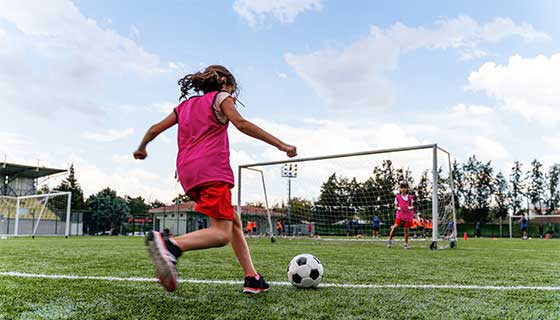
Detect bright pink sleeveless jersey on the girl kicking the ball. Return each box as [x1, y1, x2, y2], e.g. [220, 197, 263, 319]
[175, 91, 234, 192]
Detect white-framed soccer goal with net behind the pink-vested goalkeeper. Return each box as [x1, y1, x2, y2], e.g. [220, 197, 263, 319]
[237, 144, 457, 249]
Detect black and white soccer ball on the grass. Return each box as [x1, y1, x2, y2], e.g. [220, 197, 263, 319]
[288, 253, 323, 288]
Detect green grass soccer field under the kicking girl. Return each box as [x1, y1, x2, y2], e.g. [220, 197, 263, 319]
[0, 237, 560, 319]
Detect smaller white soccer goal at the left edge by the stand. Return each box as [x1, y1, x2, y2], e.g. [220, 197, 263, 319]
[0, 192, 75, 237]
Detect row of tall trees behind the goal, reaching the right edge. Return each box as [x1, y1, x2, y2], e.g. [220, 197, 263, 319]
[275, 155, 560, 223]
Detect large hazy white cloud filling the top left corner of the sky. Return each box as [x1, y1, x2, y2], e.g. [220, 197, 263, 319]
[0, 0, 170, 116]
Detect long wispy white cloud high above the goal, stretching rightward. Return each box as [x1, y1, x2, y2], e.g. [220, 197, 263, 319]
[285, 16, 548, 110]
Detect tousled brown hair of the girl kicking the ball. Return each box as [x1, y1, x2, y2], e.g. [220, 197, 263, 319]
[178, 65, 238, 100]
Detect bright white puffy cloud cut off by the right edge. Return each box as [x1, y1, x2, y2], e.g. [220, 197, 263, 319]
[467, 53, 560, 124]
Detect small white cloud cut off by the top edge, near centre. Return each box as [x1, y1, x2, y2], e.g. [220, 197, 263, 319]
[233, 0, 321, 27]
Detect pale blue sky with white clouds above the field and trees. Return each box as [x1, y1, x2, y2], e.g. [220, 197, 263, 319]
[0, 0, 560, 201]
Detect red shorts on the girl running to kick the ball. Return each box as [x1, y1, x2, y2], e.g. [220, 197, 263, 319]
[187, 182, 233, 221]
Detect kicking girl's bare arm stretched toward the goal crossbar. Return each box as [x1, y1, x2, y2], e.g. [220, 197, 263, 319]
[220, 98, 297, 158]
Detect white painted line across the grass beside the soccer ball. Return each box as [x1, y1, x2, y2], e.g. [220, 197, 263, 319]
[0, 272, 560, 291]
